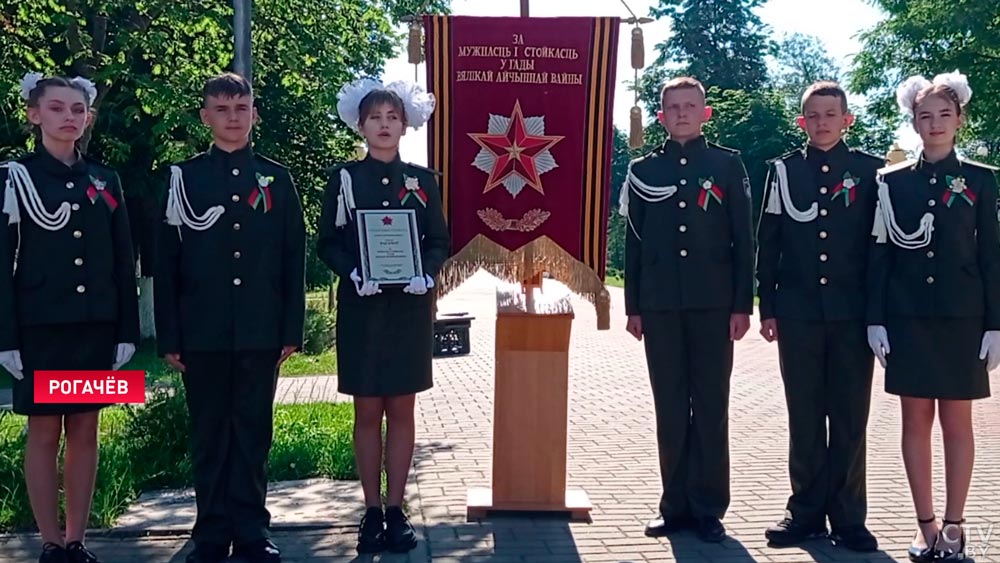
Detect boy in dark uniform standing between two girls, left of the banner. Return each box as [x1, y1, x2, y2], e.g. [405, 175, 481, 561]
[155, 74, 305, 563]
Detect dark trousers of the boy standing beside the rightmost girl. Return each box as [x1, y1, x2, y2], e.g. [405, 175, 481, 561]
[778, 319, 874, 528]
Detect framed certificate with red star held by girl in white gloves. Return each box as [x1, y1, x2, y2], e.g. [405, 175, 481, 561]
[356, 209, 424, 286]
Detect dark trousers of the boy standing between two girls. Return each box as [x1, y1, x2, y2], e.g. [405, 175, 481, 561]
[181, 350, 280, 546]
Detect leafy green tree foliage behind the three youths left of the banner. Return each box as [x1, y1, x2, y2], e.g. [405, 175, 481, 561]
[0, 0, 448, 283]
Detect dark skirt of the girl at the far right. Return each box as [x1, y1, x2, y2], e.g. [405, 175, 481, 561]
[885, 317, 990, 400]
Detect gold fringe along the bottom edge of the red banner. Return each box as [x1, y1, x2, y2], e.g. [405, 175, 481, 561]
[434, 235, 611, 330]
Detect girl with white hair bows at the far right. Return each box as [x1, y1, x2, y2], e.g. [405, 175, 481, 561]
[868, 72, 1000, 561]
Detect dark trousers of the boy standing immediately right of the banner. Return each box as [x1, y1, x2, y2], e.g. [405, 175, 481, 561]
[642, 310, 733, 519]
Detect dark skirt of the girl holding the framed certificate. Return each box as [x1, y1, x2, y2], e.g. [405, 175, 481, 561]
[337, 283, 434, 397]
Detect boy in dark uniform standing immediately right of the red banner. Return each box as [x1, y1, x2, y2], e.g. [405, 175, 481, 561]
[621, 78, 753, 542]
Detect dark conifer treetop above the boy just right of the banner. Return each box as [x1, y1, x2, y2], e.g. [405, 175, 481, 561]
[650, 0, 768, 90]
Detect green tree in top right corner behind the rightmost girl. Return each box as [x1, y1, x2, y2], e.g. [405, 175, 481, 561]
[851, 0, 1000, 161]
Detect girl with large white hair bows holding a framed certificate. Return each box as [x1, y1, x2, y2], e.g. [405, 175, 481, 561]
[317, 80, 449, 553]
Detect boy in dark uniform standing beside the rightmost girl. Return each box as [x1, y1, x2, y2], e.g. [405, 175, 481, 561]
[757, 82, 883, 551]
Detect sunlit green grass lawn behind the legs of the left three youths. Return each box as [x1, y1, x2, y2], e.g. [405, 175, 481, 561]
[0, 388, 357, 532]
